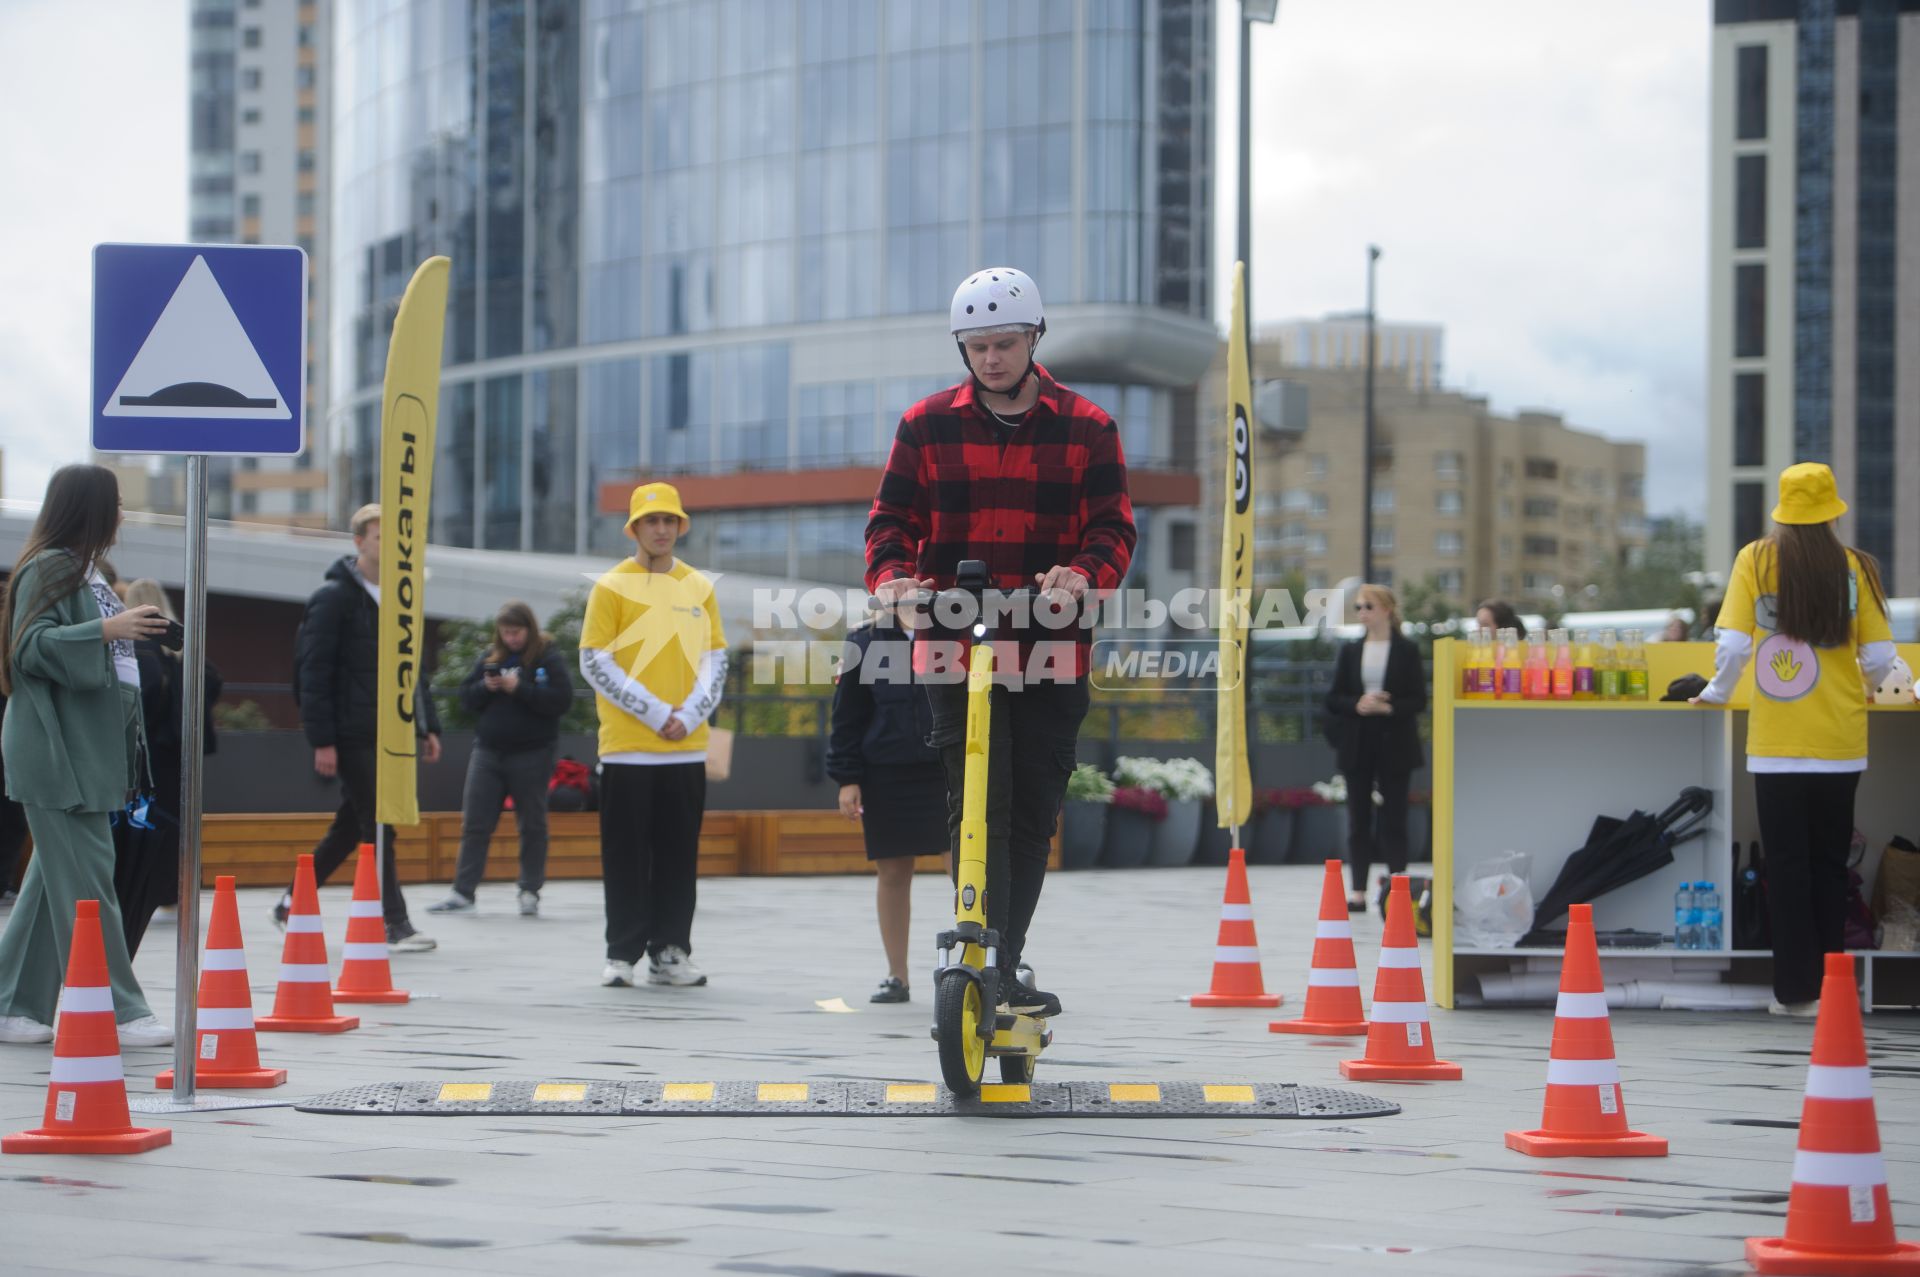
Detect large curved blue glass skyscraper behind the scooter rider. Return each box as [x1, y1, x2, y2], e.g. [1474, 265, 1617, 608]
[328, 0, 1215, 582]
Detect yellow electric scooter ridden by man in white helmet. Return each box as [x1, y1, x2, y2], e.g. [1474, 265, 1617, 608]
[887, 559, 1054, 1098]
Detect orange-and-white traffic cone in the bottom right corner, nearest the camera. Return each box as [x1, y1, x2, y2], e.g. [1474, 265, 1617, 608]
[1747, 952, 1920, 1277]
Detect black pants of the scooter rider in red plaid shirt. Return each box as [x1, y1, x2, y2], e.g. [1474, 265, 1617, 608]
[927, 680, 1087, 968]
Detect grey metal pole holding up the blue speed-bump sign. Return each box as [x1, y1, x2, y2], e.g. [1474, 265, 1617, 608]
[171, 455, 207, 1106]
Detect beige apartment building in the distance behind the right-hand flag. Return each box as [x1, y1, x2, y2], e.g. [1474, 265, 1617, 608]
[1200, 342, 1647, 611]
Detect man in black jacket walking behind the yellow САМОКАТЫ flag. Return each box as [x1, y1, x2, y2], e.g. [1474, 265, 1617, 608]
[273, 505, 440, 952]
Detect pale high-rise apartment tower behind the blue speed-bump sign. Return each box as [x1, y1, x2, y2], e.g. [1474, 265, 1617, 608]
[178, 0, 330, 526]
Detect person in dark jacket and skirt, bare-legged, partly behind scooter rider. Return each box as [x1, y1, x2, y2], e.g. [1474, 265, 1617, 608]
[828, 611, 947, 1002]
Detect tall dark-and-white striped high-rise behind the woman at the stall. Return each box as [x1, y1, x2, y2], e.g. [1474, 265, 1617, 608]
[1707, 0, 1920, 595]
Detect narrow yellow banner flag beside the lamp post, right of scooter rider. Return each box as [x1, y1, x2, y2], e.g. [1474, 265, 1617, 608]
[1213, 261, 1254, 830]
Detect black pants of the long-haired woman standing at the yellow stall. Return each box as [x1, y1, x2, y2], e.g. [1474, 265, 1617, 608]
[1753, 772, 1860, 1002]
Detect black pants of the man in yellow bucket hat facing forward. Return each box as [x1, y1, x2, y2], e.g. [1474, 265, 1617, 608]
[601, 762, 707, 962]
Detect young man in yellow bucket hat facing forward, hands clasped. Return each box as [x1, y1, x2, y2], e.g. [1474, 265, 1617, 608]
[580, 484, 726, 987]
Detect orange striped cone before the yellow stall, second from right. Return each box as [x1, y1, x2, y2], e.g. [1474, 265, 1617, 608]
[1507, 904, 1667, 1158]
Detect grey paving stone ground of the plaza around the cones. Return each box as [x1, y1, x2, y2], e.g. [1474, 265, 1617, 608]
[0, 866, 1920, 1277]
